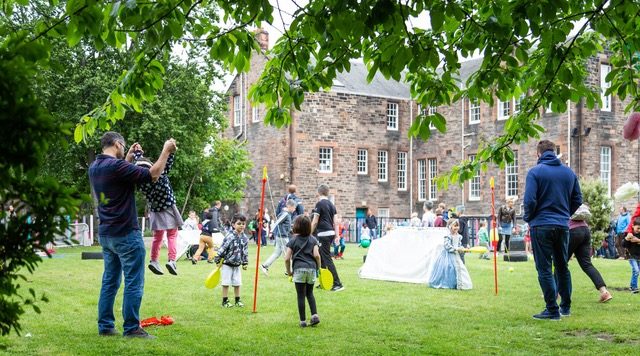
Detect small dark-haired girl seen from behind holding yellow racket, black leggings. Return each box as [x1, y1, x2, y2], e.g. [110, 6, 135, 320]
[284, 215, 320, 328]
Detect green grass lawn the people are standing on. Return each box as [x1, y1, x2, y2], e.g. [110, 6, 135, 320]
[0, 241, 640, 355]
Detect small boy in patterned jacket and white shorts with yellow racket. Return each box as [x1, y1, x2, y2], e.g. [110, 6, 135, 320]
[214, 213, 249, 308]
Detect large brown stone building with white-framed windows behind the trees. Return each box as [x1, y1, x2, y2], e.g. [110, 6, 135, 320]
[225, 32, 640, 218]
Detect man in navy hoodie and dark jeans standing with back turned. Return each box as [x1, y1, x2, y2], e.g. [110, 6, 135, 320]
[524, 140, 582, 320]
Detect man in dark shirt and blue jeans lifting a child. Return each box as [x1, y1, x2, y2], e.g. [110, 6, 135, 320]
[89, 131, 176, 339]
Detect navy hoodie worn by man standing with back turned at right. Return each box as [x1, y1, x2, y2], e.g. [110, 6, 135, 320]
[523, 151, 582, 228]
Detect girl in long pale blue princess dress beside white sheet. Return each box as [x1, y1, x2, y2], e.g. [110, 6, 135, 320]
[429, 218, 473, 289]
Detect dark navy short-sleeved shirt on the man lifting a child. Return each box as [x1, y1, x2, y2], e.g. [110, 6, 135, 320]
[89, 154, 151, 237]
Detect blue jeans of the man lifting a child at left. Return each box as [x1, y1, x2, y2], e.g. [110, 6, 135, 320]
[98, 230, 146, 334]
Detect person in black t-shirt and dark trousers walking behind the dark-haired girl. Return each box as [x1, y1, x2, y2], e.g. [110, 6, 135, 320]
[311, 184, 344, 292]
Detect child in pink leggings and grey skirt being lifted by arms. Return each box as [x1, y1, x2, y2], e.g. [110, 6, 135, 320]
[134, 151, 184, 276]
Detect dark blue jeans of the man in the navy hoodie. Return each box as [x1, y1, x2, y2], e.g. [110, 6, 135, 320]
[531, 226, 571, 313]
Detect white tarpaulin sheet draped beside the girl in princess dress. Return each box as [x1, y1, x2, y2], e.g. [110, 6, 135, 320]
[359, 227, 449, 284]
